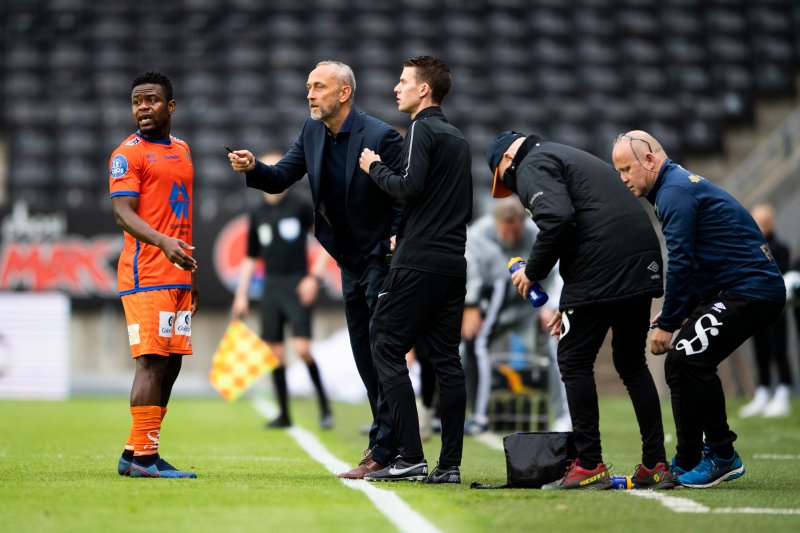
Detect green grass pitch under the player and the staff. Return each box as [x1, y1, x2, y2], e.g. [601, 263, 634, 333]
[0, 397, 800, 533]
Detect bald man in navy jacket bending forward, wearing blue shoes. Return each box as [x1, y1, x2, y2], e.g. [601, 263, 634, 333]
[612, 130, 786, 488]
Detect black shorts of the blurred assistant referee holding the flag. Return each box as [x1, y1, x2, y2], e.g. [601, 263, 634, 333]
[261, 274, 311, 342]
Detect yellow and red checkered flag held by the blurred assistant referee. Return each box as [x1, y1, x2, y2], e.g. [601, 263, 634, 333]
[208, 320, 280, 402]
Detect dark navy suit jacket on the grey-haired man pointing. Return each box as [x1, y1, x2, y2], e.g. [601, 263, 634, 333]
[246, 108, 403, 269]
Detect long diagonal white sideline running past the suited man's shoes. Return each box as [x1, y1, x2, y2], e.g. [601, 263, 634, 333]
[253, 398, 441, 533]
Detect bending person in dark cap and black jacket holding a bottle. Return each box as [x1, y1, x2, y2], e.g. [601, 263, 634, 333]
[487, 131, 674, 490]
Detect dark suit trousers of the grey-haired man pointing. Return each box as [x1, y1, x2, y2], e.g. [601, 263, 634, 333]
[341, 251, 397, 465]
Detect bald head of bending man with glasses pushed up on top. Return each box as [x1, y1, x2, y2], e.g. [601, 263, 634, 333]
[611, 130, 667, 197]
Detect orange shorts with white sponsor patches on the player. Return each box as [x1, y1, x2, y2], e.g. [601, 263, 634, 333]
[121, 289, 192, 358]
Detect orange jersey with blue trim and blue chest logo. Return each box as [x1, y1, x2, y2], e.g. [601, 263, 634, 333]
[108, 133, 194, 295]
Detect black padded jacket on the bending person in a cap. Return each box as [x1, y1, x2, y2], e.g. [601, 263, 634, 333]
[504, 135, 663, 310]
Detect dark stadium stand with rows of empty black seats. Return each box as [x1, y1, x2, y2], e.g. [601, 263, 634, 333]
[0, 0, 800, 209]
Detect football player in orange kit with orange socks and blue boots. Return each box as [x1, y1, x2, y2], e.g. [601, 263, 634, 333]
[109, 72, 199, 478]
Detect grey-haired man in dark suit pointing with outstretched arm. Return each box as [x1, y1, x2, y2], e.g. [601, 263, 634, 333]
[228, 61, 403, 479]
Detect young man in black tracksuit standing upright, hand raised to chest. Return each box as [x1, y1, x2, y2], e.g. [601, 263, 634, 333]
[359, 56, 472, 483]
